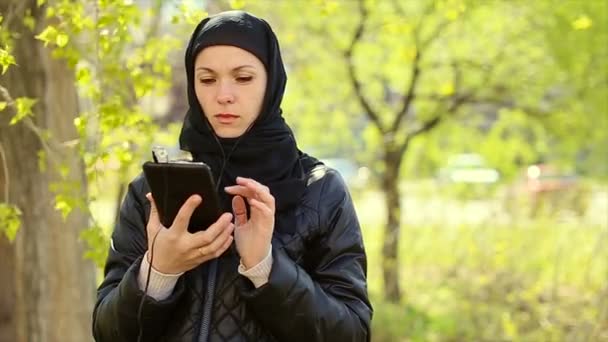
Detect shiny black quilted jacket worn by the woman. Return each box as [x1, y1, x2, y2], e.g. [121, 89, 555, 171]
[93, 159, 372, 342]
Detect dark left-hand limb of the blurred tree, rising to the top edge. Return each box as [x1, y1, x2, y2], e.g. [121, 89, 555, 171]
[344, 0, 386, 134]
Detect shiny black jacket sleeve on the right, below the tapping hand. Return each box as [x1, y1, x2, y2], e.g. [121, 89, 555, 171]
[243, 171, 372, 342]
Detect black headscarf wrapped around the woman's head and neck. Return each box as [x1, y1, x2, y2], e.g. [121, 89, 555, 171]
[179, 11, 306, 218]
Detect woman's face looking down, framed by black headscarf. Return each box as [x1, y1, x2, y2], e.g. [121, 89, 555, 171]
[194, 45, 267, 138]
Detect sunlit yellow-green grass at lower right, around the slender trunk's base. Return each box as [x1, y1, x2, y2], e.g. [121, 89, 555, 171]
[360, 207, 608, 341]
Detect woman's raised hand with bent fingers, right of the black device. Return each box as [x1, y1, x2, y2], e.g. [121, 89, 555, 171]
[225, 177, 275, 269]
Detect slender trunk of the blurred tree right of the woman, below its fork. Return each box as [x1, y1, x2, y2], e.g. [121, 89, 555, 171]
[382, 146, 402, 303]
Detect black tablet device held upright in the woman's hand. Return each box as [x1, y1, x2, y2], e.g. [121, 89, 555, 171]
[143, 162, 222, 233]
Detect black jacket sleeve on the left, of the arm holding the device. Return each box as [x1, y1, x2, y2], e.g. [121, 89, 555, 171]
[93, 177, 184, 342]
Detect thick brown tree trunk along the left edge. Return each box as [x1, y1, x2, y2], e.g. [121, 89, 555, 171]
[0, 0, 95, 342]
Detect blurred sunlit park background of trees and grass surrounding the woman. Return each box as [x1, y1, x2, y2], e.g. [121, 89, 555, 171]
[0, 0, 608, 341]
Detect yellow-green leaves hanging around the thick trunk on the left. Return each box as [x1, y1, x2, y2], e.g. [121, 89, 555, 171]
[0, 0, 184, 265]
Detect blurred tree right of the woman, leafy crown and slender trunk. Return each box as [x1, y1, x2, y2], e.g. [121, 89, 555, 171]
[252, 0, 608, 301]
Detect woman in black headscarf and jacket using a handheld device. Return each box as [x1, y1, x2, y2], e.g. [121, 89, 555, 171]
[93, 11, 372, 342]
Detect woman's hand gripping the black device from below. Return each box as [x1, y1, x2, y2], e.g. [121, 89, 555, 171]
[146, 193, 234, 274]
